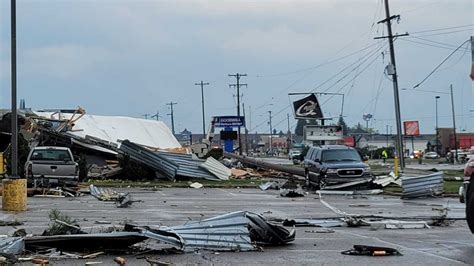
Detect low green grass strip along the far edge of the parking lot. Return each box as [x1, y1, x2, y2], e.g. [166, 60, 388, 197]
[85, 179, 266, 188]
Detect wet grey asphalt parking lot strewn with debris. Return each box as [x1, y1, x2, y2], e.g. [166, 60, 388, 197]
[0, 188, 474, 265]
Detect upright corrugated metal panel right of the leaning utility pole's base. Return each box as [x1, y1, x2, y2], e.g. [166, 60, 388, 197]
[401, 172, 443, 198]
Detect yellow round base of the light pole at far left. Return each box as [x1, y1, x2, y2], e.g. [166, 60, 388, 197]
[2, 179, 27, 212]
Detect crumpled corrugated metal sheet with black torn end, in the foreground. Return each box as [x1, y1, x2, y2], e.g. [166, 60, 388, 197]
[137, 211, 295, 252]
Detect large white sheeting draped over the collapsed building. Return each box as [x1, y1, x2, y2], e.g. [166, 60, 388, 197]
[35, 112, 181, 149]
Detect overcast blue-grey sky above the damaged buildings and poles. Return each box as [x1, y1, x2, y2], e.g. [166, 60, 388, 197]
[0, 0, 474, 133]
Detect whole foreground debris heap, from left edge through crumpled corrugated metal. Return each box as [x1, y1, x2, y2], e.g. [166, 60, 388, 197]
[0, 211, 295, 262]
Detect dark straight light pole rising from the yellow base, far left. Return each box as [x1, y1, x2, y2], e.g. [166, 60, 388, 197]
[11, 0, 19, 178]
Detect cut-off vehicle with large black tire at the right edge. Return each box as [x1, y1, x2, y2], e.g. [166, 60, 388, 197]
[459, 158, 474, 233]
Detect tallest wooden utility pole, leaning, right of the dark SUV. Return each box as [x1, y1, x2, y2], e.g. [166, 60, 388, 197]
[374, 0, 408, 170]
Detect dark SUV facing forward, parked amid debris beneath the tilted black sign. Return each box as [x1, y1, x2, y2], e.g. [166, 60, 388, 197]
[304, 145, 373, 189]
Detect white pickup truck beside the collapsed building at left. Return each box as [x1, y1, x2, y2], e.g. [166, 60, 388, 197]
[25, 146, 79, 187]
